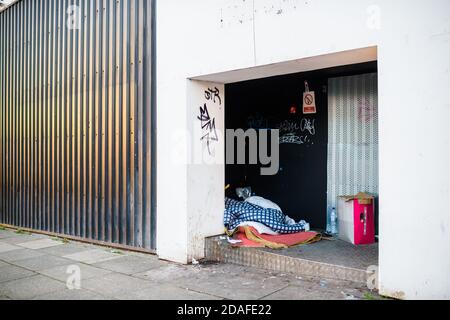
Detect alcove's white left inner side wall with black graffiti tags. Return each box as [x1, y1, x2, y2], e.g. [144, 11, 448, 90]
[187, 80, 225, 261]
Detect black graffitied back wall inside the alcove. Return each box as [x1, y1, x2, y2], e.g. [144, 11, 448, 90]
[225, 62, 377, 229]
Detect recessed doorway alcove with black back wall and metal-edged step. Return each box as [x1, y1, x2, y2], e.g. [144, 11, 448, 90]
[190, 48, 378, 282]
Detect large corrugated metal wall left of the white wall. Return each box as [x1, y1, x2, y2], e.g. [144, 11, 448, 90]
[0, 0, 155, 250]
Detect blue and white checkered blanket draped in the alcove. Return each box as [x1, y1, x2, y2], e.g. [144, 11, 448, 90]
[224, 198, 305, 234]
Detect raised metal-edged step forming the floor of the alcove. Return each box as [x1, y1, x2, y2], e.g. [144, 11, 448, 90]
[205, 236, 378, 283]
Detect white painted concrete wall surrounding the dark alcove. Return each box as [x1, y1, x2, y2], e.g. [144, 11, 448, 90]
[157, 0, 450, 299]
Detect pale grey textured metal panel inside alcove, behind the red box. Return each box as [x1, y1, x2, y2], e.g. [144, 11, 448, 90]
[328, 73, 378, 212]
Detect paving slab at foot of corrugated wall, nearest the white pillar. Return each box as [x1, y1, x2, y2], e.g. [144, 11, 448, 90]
[93, 255, 168, 275]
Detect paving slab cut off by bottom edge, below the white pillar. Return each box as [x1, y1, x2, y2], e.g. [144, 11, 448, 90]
[114, 284, 221, 300]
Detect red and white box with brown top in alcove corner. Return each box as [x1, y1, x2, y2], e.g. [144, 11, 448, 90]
[337, 193, 375, 245]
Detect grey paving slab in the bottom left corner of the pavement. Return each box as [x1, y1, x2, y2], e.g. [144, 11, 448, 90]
[0, 275, 65, 300]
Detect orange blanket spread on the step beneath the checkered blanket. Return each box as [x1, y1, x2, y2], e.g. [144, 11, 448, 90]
[233, 227, 322, 249]
